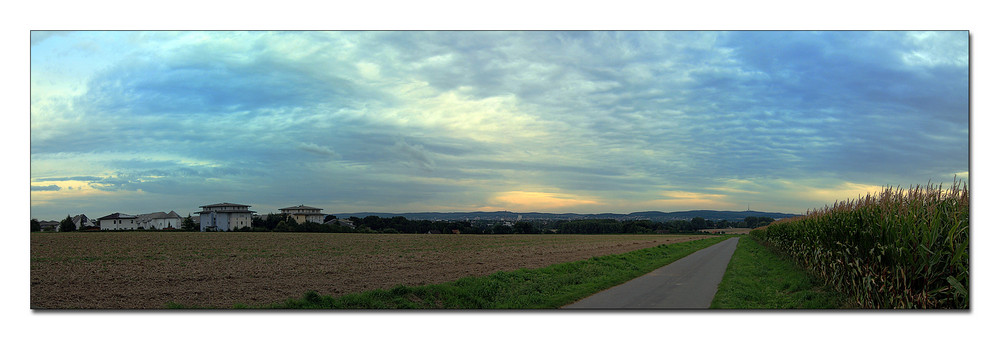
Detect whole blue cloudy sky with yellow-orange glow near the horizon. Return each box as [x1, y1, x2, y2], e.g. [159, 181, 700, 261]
[30, 31, 969, 219]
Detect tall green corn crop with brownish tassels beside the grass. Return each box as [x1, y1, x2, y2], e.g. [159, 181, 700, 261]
[750, 181, 970, 309]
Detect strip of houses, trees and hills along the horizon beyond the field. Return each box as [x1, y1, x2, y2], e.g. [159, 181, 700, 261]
[31, 202, 796, 234]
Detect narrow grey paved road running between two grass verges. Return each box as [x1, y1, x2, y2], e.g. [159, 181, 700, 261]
[563, 237, 739, 309]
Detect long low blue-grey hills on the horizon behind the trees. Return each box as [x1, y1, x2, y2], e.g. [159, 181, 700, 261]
[331, 210, 798, 221]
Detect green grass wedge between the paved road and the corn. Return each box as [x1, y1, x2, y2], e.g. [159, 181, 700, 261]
[710, 237, 845, 309]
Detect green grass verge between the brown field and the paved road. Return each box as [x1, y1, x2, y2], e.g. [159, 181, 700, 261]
[174, 237, 727, 309]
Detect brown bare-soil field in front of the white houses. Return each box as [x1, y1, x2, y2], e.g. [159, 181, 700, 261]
[31, 232, 709, 309]
